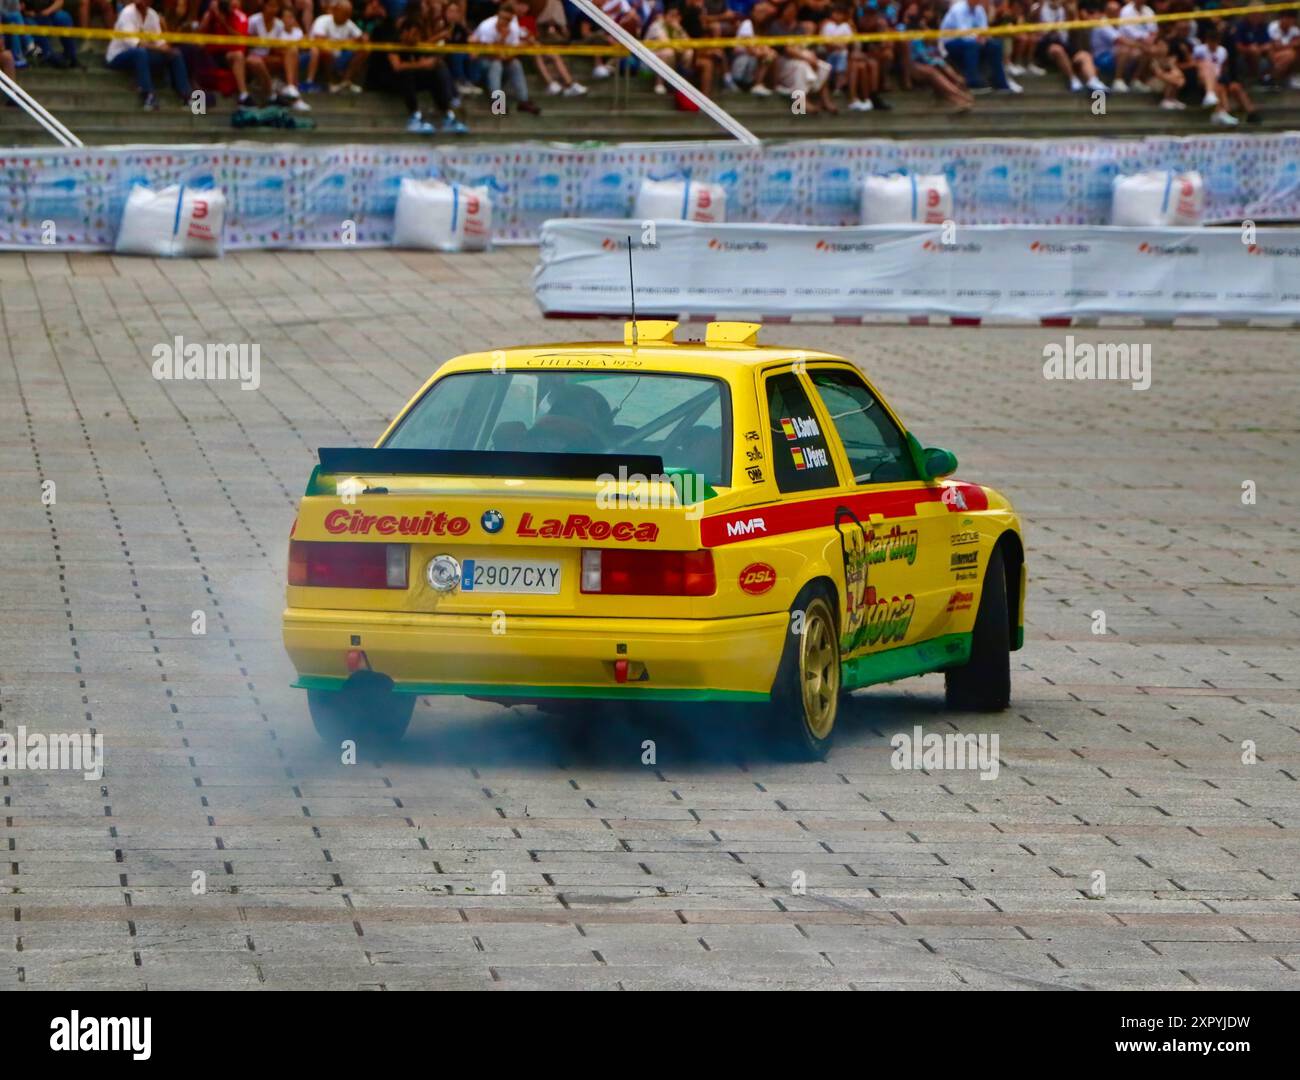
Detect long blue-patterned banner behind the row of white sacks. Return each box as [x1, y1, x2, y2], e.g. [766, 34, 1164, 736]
[0, 131, 1300, 251]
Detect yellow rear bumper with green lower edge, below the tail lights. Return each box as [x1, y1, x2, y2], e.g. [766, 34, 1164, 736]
[283, 608, 789, 701]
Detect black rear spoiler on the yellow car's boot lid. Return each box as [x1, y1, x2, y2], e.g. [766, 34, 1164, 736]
[307, 446, 664, 494]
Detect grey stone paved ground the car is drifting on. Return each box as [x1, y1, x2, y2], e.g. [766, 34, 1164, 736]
[0, 251, 1300, 989]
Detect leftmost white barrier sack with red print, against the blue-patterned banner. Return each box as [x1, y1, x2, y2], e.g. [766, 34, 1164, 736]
[113, 185, 226, 259]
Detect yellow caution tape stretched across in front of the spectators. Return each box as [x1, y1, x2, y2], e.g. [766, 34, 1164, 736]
[0, 0, 1300, 56]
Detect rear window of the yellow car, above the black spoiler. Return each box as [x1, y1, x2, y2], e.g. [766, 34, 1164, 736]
[384, 369, 731, 486]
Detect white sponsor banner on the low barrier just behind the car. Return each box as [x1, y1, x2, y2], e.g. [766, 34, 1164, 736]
[533, 220, 1300, 318]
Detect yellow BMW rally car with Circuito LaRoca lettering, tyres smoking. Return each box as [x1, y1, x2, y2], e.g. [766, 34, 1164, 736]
[283, 321, 1026, 756]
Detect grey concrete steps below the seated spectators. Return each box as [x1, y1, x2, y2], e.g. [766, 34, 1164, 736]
[0, 57, 1300, 146]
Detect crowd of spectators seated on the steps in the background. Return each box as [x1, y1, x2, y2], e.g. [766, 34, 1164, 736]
[0, 0, 1300, 134]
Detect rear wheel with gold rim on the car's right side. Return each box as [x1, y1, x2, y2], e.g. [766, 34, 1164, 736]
[767, 586, 840, 762]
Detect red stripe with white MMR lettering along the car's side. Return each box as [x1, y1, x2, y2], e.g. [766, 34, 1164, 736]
[699, 481, 988, 547]
